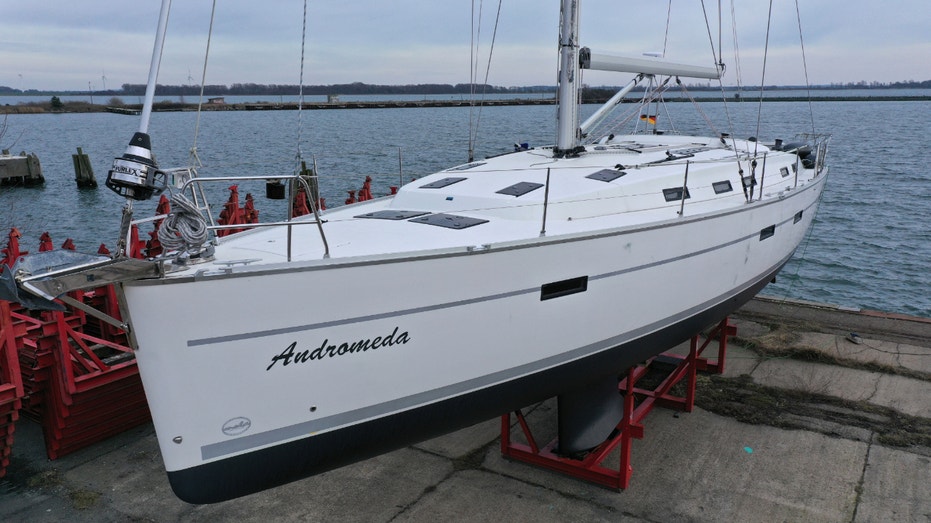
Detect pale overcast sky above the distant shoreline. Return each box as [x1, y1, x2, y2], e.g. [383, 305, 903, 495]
[0, 0, 931, 90]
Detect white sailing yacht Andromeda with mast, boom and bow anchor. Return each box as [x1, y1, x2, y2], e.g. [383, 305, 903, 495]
[4, 0, 828, 503]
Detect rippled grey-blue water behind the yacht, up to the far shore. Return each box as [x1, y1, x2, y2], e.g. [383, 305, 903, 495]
[0, 101, 931, 317]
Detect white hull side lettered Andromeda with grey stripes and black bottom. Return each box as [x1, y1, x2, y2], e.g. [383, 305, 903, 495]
[123, 176, 825, 503]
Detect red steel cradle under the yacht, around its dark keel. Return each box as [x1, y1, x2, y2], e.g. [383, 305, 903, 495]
[501, 318, 737, 490]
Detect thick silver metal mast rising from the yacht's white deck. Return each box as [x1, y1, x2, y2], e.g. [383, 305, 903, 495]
[553, 0, 580, 158]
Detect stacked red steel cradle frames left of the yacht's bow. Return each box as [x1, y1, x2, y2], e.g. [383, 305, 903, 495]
[0, 229, 150, 462]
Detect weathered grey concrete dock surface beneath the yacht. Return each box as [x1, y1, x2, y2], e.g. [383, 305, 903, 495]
[0, 299, 931, 523]
